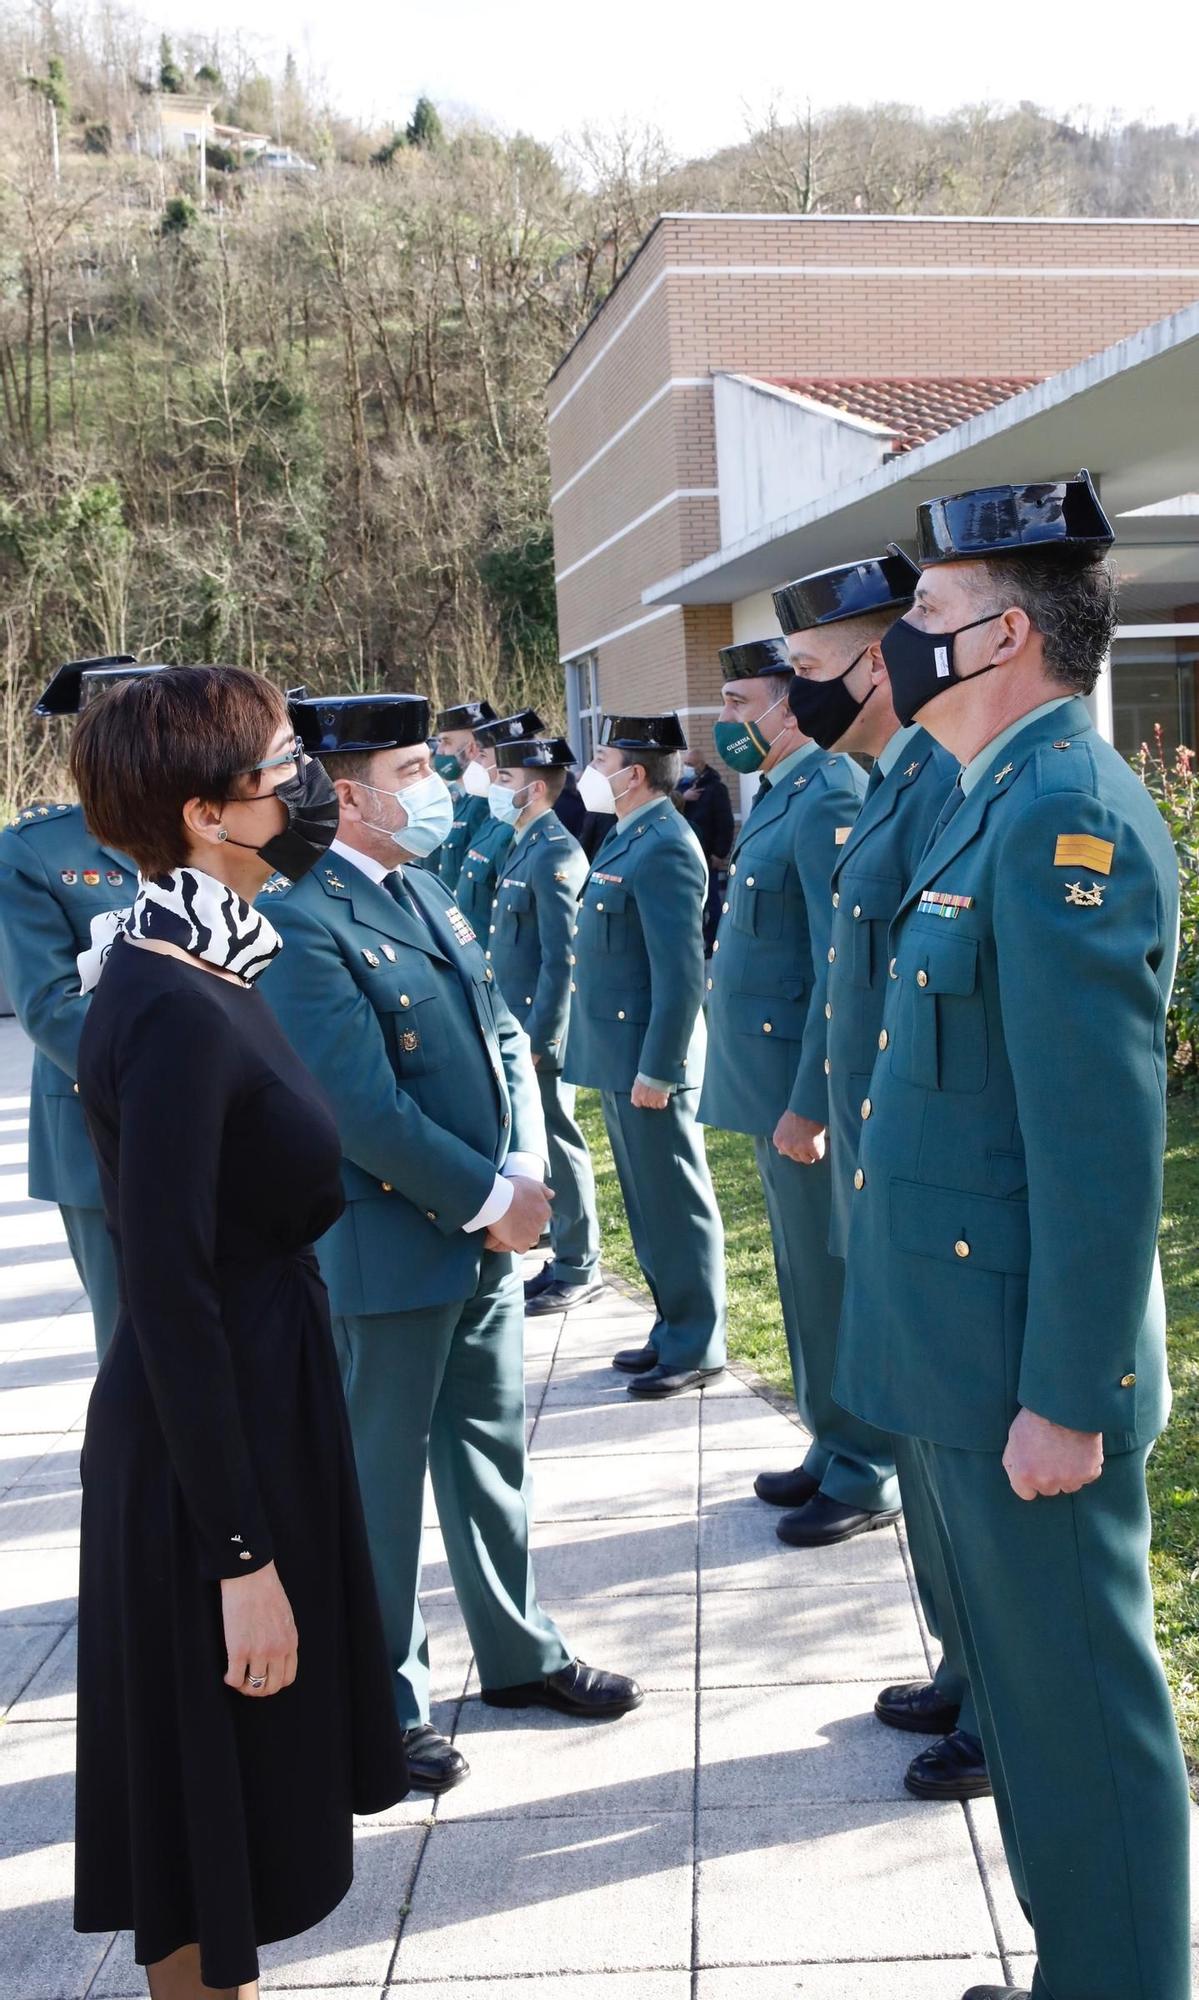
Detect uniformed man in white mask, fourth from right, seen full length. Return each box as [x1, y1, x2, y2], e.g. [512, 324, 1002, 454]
[566, 714, 725, 1396]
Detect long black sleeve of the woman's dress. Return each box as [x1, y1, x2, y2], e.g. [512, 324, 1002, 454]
[116, 994, 272, 1578]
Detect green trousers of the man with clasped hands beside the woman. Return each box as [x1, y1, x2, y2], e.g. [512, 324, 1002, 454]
[334, 1252, 572, 1730]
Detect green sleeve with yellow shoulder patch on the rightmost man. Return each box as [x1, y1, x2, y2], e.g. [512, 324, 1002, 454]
[995, 792, 1173, 1432]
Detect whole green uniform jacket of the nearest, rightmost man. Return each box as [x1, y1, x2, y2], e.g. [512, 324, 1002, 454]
[833, 700, 1179, 1452]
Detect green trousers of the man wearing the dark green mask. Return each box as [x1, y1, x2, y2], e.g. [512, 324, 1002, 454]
[753, 1136, 899, 1514]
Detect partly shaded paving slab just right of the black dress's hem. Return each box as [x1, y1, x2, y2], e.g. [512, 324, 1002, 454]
[396, 1812, 693, 1996]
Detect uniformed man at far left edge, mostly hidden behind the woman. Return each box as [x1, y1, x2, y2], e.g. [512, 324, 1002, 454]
[0, 654, 158, 1358]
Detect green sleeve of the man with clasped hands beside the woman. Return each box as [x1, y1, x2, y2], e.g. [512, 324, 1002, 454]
[262, 898, 496, 1236]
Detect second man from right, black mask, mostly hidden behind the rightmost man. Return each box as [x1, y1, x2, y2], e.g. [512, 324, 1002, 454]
[773, 552, 989, 1798]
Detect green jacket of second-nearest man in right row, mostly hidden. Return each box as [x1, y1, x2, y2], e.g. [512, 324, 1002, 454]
[825, 730, 957, 1258]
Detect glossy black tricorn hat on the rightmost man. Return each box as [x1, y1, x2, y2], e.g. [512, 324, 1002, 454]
[915, 470, 1115, 564]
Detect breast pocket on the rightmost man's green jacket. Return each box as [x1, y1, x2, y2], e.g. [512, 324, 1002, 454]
[891, 928, 987, 1092]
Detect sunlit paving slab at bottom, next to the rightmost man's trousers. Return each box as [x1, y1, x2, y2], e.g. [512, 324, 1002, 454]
[697, 1800, 989, 1966]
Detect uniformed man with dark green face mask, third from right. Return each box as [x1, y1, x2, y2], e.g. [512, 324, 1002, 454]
[699, 638, 899, 1548]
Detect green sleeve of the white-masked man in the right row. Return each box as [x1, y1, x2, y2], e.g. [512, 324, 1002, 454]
[631, 836, 707, 1090]
